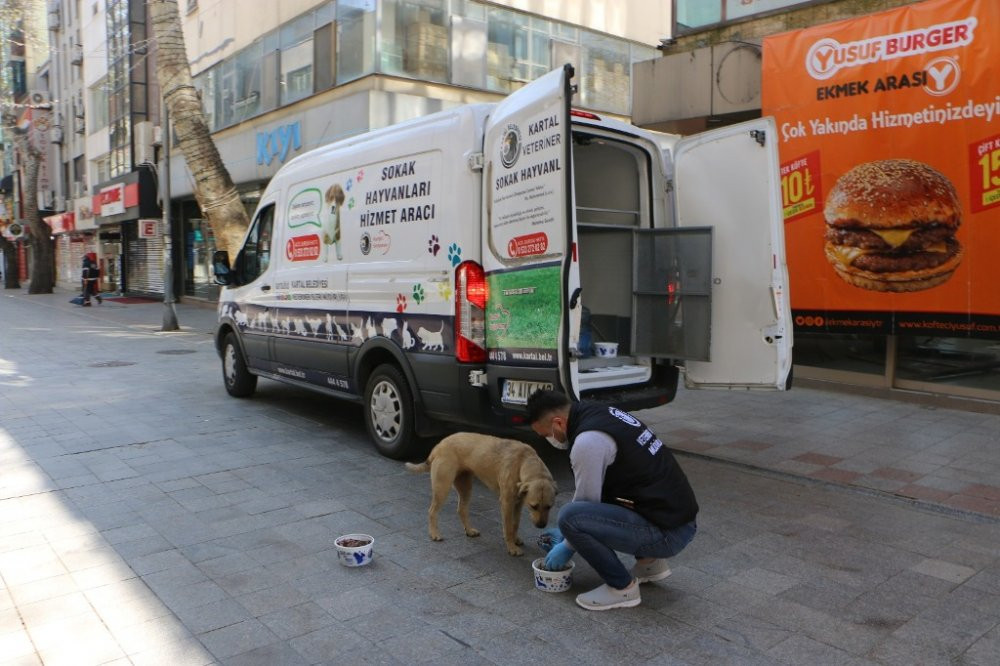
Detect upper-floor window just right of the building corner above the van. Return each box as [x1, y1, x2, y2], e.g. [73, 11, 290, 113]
[379, 0, 448, 81]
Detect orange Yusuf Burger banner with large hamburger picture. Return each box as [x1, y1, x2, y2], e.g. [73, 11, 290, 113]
[762, 0, 1000, 337]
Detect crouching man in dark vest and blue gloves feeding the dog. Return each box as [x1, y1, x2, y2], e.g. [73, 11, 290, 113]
[528, 390, 698, 610]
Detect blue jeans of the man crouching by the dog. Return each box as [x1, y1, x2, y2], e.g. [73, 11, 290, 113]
[559, 502, 698, 590]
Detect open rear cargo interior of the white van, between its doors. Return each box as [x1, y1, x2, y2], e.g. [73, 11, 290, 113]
[573, 132, 652, 391]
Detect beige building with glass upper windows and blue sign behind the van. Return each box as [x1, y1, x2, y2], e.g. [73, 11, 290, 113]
[170, 0, 668, 299]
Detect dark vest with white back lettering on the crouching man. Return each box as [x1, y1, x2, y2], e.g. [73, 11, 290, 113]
[567, 402, 698, 528]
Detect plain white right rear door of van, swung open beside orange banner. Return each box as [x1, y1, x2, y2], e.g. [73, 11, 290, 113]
[673, 118, 792, 390]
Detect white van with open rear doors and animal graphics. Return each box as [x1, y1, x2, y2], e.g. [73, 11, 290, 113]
[215, 65, 792, 458]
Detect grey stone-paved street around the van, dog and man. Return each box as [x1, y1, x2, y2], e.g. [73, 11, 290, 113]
[0, 291, 1000, 666]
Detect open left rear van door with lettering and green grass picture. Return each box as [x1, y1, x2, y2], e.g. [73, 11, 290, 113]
[482, 65, 582, 405]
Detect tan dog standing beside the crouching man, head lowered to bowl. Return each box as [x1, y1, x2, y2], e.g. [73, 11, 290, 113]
[406, 432, 556, 555]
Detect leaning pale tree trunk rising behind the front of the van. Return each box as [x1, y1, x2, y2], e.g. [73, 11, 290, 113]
[147, 0, 250, 256]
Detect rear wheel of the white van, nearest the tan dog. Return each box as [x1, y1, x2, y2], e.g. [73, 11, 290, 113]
[365, 364, 416, 460]
